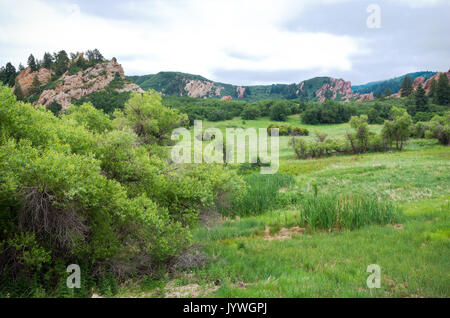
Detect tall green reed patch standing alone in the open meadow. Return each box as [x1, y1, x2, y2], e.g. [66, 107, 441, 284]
[301, 194, 400, 230]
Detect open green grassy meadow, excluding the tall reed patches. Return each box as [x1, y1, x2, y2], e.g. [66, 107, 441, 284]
[119, 116, 450, 297]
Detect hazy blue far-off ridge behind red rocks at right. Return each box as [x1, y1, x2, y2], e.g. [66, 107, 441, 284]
[352, 71, 436, 96]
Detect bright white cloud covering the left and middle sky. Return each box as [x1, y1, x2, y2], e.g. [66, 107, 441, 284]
[0, 0, 365, 83]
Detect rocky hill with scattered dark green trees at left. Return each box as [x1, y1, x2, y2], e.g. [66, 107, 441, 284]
[14, 53, 143, 112]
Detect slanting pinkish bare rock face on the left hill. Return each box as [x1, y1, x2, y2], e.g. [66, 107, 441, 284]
[35, 58, 144, 111]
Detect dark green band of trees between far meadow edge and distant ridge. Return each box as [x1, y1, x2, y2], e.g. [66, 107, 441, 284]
[163, 73, 450, 125]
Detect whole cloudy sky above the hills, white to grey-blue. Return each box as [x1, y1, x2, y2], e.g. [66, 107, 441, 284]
[0, 0, 450, 85]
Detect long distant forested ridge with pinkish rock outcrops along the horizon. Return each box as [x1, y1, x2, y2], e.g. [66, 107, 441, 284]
[127, 72, 436, 102]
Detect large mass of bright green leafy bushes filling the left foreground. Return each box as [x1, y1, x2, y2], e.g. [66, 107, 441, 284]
[0, 86, 244, 297]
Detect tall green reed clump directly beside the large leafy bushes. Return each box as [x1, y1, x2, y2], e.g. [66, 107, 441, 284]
[228, 173, 295, 216]
